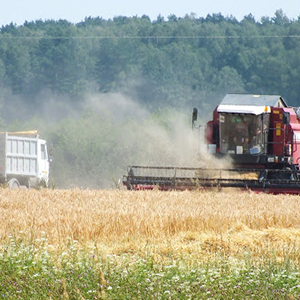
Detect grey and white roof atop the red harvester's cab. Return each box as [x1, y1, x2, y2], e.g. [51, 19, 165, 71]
[218, 94, 287, 115]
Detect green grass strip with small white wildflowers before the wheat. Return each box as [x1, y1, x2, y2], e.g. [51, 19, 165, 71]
[0, 237, 300, 300]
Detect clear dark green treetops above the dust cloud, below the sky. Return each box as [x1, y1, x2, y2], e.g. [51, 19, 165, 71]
[0, 10, 300, 108]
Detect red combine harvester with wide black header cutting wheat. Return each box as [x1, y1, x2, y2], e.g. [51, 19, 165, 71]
[123, 94, 300, 194]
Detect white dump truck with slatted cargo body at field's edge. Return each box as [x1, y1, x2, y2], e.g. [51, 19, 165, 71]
[0, 131, 49, 189]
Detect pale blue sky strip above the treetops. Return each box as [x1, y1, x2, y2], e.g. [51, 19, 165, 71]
[0, 0, 300, 26]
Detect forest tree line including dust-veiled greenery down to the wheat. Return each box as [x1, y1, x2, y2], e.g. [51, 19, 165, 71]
[0, 10, 300, 186]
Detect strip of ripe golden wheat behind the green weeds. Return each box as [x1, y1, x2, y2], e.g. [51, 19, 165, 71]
[0, 189, 300, 261]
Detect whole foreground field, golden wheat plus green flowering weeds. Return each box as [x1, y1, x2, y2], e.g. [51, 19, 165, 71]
[0, 189, 300, 299]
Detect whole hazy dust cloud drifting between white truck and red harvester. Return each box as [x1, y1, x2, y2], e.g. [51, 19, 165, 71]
[0, 90, 229, 188]
